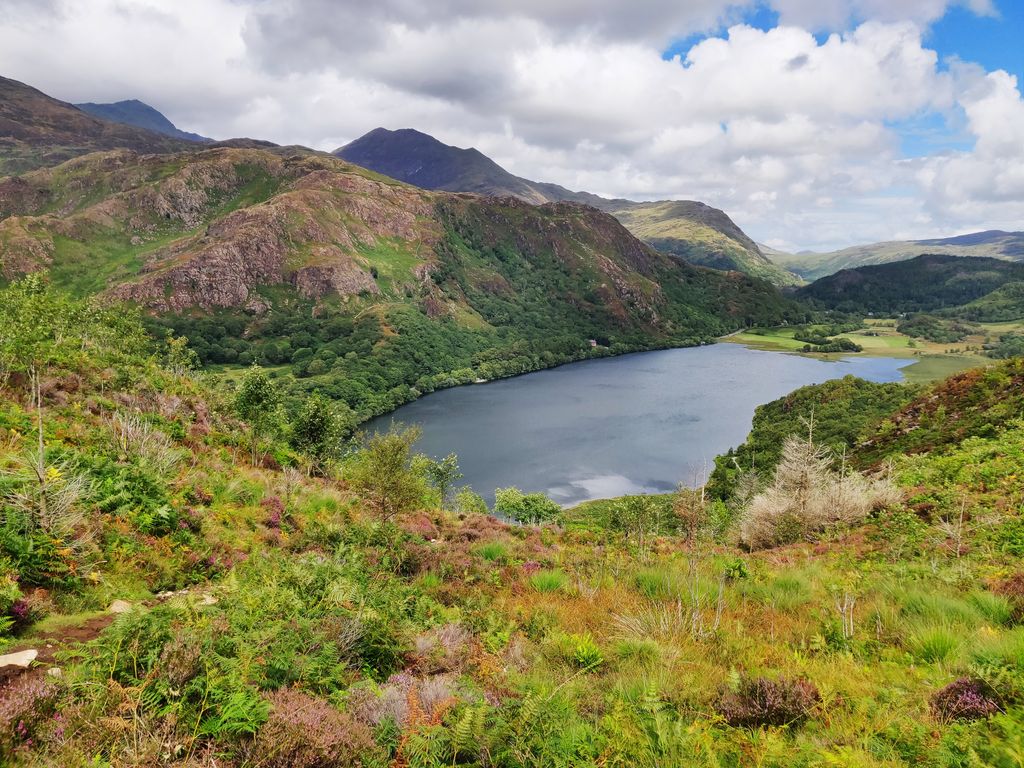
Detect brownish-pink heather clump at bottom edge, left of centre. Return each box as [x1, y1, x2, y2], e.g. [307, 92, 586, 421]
[250, 688, 378, 768]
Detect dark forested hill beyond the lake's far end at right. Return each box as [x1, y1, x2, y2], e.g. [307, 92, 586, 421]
[796, 254, 1024, 316]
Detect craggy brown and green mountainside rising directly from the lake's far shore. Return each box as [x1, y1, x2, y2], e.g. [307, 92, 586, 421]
[0, 147, 806, 417]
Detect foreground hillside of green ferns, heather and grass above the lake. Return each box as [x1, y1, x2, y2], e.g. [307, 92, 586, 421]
[0, 276, 1024, 768]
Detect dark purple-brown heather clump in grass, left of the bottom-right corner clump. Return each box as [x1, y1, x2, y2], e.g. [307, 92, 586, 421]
[716, 677, 821, 727]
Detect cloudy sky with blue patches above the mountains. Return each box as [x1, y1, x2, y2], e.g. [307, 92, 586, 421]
[0, 0, 1024, 251]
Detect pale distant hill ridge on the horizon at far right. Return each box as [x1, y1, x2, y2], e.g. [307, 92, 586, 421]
[771, 229, 1024, 282]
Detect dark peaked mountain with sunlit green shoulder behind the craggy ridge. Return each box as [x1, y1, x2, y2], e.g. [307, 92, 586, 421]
[334, 128, 801, 286]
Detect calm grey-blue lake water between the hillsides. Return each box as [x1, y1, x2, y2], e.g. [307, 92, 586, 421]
[367, 344, 912, 505]
